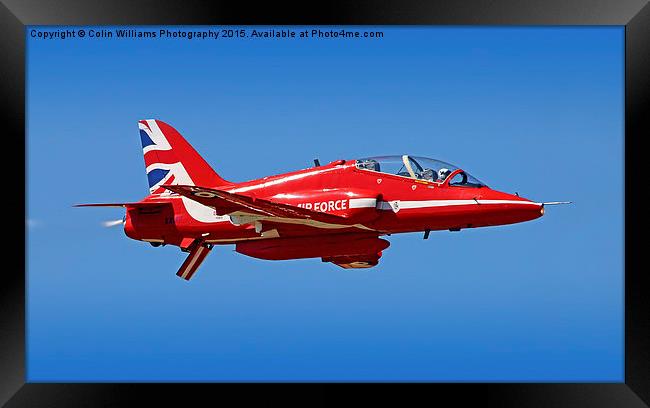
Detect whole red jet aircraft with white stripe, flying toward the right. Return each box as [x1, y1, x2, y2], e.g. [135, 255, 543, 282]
[78, 120, 564, 280]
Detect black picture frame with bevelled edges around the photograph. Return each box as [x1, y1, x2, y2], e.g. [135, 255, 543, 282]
[0, 0, 650, 407]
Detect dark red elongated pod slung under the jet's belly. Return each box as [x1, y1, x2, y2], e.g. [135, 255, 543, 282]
[235, 234, 390, 260]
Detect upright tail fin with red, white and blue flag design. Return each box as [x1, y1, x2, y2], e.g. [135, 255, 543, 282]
[138, 119, 231, 194]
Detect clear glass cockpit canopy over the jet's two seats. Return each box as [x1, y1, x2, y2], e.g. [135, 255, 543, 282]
[356, 154, 485, 187]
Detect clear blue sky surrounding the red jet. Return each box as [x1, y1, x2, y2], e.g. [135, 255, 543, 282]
[26, 27, 624, 382]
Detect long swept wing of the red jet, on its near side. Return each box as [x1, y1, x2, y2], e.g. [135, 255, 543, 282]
[163, 185, 354, 225]
